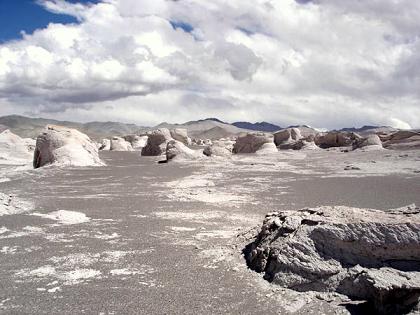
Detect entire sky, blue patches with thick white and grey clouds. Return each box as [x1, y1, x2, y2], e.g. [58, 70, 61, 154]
[0, 0, 420, 129]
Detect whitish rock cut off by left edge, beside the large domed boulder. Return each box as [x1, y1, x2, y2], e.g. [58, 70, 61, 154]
[0, 129, 35, 165]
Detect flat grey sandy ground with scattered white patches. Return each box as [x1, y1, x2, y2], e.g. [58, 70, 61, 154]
[0, 150, 420, 314]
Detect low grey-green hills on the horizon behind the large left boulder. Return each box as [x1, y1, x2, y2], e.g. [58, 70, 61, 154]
[0, 115, 145, 140]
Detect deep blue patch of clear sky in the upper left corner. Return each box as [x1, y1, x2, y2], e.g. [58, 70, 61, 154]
[0, 0, 99, 43]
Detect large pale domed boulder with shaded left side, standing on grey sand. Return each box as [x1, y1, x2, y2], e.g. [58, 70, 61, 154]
[33, 125, 104, 168]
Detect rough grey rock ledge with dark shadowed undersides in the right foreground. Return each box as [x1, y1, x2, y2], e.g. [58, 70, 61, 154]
[245, 206, 420, 314]
